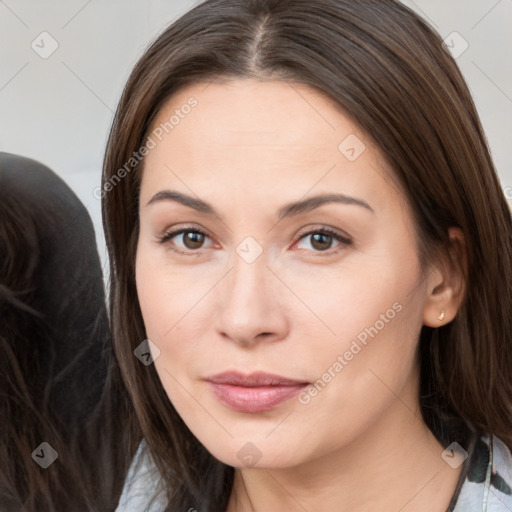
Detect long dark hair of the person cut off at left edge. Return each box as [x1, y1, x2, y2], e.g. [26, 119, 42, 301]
[0, 153, 133, 512]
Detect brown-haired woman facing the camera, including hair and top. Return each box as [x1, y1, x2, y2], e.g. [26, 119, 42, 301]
[101, 0, 512, 512]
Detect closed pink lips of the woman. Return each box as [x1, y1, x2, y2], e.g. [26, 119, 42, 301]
[206, 372, 309, 412]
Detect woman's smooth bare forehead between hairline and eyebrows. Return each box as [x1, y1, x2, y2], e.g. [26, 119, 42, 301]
[142, 79, 404, 212]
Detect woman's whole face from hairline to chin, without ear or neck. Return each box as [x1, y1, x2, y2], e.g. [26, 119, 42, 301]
[136, 80, 427, 468]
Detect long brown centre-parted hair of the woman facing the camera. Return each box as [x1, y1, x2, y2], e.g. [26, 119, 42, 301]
[101, 0, 512, 511]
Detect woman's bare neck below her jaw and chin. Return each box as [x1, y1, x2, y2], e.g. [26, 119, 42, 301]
[226, 394, 462, 512]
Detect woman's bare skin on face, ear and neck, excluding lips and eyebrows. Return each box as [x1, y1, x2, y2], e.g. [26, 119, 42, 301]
[136, 80, 464, 512]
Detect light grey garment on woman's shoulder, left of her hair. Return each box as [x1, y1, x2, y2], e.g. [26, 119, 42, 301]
[115, 441, 166, 512]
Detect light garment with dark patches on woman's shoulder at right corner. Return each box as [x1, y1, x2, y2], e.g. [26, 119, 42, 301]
[454, 435, 512, 512]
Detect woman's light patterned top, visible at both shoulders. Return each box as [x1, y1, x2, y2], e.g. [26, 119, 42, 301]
[116, 434, 512, 512]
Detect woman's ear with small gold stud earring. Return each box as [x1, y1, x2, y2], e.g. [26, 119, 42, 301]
[423, 227, 468, 327]
